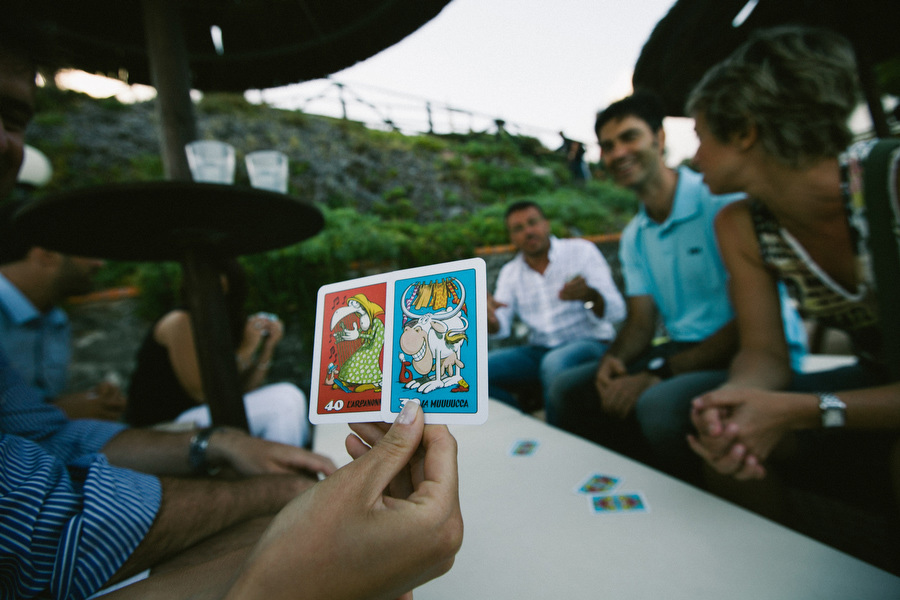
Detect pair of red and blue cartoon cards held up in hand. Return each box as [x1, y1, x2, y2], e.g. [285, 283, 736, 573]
[309, 258, 488, 424]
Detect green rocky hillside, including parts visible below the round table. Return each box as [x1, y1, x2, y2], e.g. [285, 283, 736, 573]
[29, 89, 634, 398]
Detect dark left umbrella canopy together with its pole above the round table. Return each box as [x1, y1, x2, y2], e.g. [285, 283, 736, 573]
[24, 0, 450, 180]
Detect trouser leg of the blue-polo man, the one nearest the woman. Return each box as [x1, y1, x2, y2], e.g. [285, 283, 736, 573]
[634, 371, 728, 482]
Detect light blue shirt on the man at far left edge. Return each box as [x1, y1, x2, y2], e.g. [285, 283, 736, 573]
[0, 275, 71, 398]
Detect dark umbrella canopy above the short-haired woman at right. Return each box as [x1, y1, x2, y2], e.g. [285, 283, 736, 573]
[632, 0, 900, 135]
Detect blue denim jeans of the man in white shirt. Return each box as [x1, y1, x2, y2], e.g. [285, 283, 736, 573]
[488, 339, 609, 408]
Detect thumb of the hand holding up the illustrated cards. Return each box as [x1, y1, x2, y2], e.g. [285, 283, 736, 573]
[352, 400, 425, 499]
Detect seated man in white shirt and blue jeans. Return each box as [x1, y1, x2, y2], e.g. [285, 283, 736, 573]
[488, 201, 625, 406]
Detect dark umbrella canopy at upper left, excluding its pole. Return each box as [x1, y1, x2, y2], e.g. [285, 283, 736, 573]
[35, 0, 449, 92]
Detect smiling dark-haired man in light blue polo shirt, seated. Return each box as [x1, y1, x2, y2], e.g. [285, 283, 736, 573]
[547, 92, 805, 479]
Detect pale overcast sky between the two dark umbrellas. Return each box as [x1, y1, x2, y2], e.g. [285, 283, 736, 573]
[253, 0, 696, 162]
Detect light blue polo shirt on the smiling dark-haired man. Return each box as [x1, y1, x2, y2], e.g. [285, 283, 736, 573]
[619, 167, 807, 368]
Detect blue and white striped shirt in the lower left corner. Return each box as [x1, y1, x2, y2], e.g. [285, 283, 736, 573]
[0, 353, 162, 599]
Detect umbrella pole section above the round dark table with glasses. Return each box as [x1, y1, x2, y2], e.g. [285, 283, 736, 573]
[142, 0, 197, 181]
